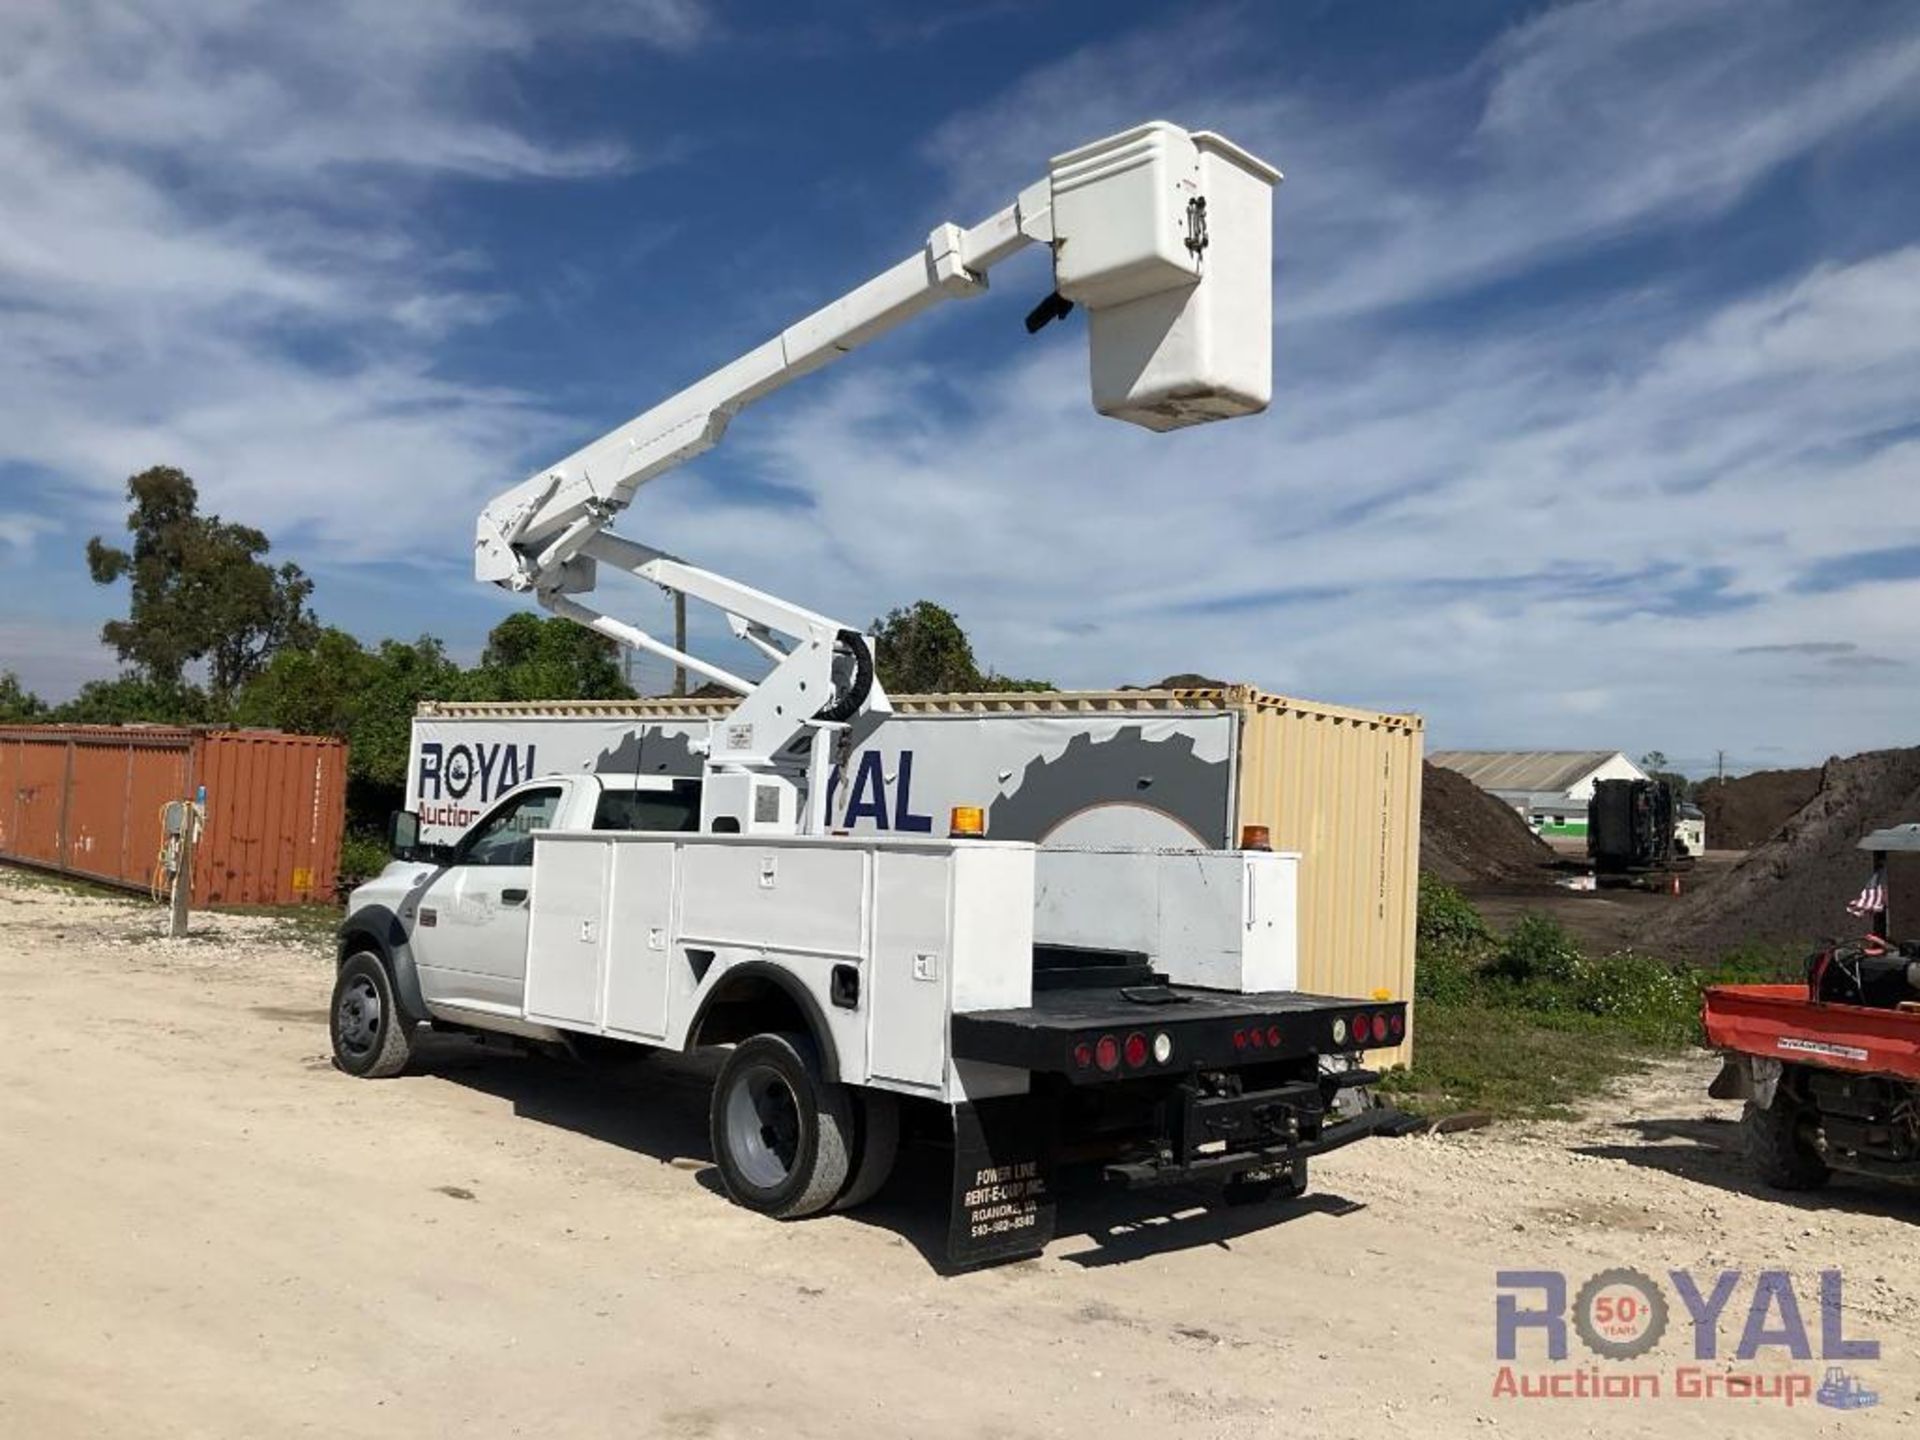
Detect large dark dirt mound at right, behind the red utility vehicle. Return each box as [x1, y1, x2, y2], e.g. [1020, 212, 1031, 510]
[1644, 747, 1920, 952]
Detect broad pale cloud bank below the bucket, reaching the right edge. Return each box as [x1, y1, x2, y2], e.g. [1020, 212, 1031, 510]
[660, 250, 1920, 733]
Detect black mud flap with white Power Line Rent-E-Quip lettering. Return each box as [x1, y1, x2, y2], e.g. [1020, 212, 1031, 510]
[947, 1094, 1054, 1269]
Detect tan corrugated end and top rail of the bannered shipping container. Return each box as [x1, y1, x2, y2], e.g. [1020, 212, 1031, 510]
[419, 685, 1425, 1064]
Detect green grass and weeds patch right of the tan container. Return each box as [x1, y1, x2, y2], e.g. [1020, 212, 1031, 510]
[1380, 877, 1803, 1117]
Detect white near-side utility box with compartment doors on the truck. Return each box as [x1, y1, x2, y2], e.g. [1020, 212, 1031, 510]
[524, 831, 1035, 1098]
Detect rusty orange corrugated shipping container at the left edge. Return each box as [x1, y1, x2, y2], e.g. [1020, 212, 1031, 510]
[0, 726, 348, 904]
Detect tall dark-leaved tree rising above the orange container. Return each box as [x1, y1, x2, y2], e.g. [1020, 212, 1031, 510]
[86, 465, 315, 705]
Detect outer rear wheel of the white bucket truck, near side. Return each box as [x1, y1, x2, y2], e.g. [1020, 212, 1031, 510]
[708, 1035, 854, 1219]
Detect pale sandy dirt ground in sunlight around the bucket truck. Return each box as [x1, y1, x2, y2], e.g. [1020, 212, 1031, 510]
[0, 874, 1920, 1440]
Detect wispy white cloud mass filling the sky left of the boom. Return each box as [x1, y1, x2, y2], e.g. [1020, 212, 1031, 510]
[0, 0, 707, 563]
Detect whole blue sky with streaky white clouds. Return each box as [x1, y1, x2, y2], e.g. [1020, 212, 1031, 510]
[0, 0, 1920, 768]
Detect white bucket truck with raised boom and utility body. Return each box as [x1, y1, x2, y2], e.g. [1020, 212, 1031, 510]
[332, 123, 1407, 1265]
